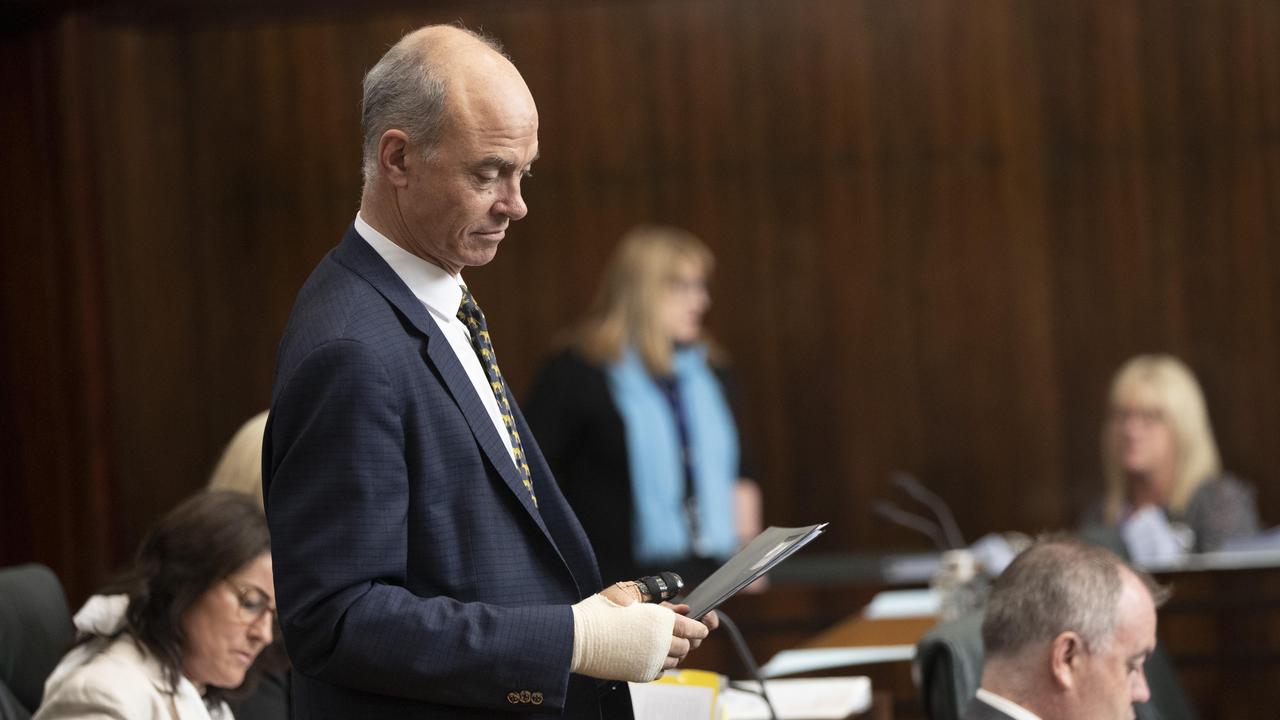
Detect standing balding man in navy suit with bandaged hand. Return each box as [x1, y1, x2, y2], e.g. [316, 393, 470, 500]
[262, 26, 717, 720]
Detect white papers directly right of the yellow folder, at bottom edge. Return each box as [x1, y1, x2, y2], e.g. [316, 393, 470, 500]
[719, 678, 872, 720]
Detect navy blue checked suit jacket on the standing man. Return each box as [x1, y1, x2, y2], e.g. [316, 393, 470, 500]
[262, 228, 625, 719]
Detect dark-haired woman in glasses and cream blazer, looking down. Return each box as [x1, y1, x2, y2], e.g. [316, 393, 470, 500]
[36, 492, 275, 720]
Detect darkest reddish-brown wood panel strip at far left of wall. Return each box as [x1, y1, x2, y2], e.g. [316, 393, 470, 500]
[0, 14, 117, 597]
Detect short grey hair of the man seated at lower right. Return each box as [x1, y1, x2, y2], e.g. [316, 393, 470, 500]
[982, 537, 1169, 656]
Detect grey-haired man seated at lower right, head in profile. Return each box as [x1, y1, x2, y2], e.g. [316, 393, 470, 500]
[964, 541, 1166, 720]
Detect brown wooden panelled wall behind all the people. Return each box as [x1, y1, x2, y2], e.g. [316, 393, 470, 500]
[0, 0, 1280, 598]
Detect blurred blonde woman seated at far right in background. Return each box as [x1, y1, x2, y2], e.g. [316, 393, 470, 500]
[1087, 355, 1258, 562]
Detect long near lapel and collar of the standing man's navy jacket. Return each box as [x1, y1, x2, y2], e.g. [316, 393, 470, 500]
[334, 225, 563, 543]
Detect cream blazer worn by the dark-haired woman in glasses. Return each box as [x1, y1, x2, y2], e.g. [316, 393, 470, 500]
[32, 634, 232, 720]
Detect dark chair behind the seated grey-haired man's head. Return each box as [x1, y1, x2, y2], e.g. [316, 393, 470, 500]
[913, 604, 1197, 720]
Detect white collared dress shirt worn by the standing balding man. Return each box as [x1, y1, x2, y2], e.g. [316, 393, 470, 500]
[356, 213, 520, 468]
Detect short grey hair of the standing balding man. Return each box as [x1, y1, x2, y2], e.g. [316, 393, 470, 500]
[361, 27, 509, 186]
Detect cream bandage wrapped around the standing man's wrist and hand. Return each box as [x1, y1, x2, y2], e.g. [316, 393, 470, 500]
[570, 594, 676, 683]
